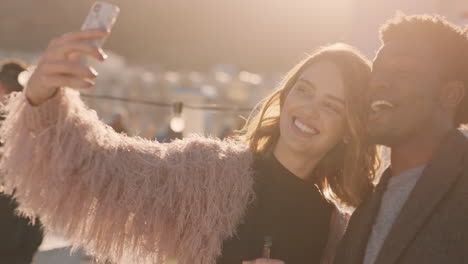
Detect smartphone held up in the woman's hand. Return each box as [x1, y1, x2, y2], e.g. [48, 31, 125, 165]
[81, 1, 120, 47]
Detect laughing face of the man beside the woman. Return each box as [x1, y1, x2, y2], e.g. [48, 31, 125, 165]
[369, 40, 440, 147]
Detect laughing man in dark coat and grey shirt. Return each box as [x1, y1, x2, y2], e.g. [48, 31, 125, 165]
[335, 15, 468, 264]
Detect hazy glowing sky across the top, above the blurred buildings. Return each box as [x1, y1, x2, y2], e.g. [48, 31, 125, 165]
[0, 0, 468, 72]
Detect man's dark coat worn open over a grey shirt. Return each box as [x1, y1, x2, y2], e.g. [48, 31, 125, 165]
[334, 130, 468, 264]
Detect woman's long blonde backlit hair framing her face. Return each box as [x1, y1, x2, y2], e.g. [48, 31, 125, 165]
[239, 43, 378, 207]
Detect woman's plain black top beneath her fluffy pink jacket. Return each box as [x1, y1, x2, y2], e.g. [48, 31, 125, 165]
[217, 155, 333, 264]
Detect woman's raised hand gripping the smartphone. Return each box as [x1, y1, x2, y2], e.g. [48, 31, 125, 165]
[26, 29, 109, 105]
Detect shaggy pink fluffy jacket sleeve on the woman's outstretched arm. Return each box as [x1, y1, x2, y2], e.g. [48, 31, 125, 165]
[0, 89, 254, 264]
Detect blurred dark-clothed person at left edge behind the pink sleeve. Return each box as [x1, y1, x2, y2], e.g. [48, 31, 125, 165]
[0, 60, 43, 264]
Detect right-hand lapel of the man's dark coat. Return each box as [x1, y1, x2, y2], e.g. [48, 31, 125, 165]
[376, 130, 468, 264]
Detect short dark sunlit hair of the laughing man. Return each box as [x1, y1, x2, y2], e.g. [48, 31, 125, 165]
[380, 13, 468, 126]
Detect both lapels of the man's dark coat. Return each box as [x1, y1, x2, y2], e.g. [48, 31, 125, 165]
[335, 130, 468, 264]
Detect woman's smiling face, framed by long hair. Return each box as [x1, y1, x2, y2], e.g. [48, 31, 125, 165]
[276, 60, 345, 158]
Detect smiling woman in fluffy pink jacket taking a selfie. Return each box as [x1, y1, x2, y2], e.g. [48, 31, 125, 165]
[1, 30, 375, 264]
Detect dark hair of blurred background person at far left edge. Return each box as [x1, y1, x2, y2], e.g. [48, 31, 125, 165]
[0, 59, 27, 94]
